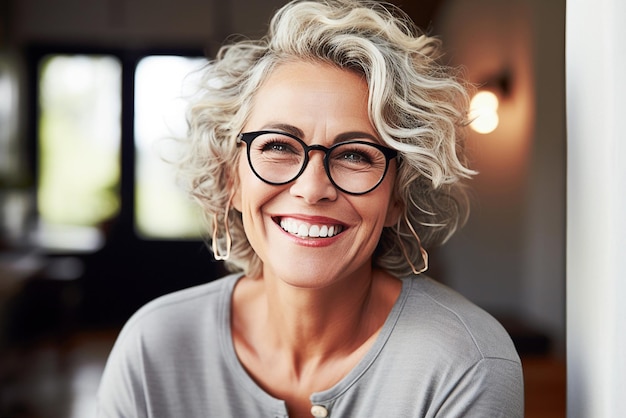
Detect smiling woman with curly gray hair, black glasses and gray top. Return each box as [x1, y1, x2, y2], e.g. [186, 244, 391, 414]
[98, 0, 523, 417]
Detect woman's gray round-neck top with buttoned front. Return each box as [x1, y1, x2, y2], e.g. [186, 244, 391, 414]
[97, 275, 524, 418]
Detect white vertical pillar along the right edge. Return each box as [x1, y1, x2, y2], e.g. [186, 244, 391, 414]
[566, 0, 626, 418]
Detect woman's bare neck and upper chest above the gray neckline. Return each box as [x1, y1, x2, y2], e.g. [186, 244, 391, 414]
[231, 269, 402, 408]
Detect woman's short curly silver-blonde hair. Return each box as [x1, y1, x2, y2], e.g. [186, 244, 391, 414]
[178, 0, 474, 277]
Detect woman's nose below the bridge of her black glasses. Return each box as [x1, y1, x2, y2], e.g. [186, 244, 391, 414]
[289, 150, 338, 204]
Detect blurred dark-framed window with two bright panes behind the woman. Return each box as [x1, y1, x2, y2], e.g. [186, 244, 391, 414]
[37, 52, 206, 252]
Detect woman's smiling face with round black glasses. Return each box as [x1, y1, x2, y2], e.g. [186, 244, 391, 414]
[233, 62, 399, 287]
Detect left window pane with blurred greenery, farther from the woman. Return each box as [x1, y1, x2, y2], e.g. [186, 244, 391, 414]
[37, 55, 121, 249]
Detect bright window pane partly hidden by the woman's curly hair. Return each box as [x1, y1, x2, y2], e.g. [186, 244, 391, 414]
[135, 56, 206, 239]
